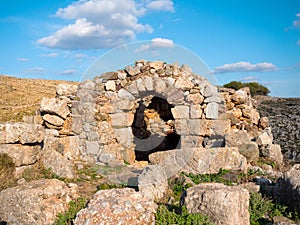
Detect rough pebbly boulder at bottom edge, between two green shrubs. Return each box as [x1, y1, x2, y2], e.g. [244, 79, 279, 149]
[74, 188, 157, 225]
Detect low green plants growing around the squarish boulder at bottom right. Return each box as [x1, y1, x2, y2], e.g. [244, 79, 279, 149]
[156, 169, 300, 225]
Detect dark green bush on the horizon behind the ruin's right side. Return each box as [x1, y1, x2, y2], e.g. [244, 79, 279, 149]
[223, 81, 270, 96]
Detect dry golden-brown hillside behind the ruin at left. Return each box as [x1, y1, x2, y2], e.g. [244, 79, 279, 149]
[0, 75, 78, 122]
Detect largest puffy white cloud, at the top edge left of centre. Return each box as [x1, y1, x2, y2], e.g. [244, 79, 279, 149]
[37, 0, 174, 49]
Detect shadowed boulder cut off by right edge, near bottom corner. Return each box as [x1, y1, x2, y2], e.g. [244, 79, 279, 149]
[274, 164, 300, 213]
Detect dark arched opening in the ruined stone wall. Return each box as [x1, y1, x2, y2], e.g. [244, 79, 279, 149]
[132, 96, 180, 161]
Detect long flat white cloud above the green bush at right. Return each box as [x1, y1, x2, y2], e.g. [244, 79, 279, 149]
[214, 62, 277, 73]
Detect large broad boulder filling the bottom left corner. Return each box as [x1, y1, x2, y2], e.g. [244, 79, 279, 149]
[0, 179, 78, 225]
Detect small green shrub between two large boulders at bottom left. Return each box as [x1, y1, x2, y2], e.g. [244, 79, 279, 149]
[53, 198, 86, 225]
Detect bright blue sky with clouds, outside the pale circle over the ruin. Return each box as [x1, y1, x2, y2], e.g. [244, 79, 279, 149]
[0, 0, 300, 97]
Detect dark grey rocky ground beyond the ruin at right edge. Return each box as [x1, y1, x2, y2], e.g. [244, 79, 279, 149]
[256, 96, 300, 163]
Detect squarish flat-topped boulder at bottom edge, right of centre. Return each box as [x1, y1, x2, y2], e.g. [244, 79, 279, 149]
[184, 183, 250, 225]
